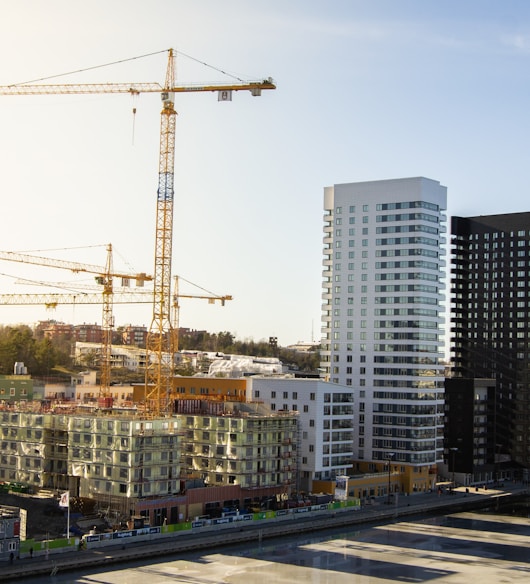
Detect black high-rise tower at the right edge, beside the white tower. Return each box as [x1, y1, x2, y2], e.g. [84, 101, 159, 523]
[451, 213, 530, 469]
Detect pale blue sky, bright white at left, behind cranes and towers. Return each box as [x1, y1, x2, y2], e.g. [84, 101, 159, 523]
[0, 0, 530, 346]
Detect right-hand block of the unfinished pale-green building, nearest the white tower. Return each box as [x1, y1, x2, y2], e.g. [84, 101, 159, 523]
[175, 399, 299, 494]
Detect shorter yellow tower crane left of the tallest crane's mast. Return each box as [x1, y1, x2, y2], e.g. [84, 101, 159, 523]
[0, 243, 153, 397]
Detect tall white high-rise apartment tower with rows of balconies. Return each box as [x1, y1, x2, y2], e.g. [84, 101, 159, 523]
[322, 177, 447, 473]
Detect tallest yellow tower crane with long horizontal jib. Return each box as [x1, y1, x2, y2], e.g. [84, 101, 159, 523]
[0, 49, 276, 416]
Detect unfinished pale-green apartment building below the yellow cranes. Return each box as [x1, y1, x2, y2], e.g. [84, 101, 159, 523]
[0, 399, 298, 525]
